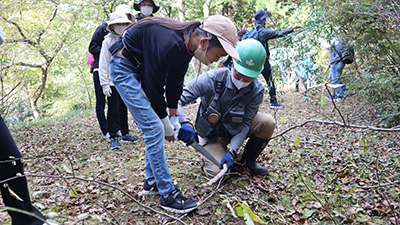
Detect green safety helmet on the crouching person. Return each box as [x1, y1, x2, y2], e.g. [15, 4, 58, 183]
[233, 39, 266, 78]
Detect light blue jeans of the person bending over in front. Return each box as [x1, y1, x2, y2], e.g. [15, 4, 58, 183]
[110, 56, 175, 195]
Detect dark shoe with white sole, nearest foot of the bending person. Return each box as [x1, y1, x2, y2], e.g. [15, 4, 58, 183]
[160, 190, 199, 213]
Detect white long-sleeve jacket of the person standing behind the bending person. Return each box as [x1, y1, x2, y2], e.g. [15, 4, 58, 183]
[99, 32, 119, 87]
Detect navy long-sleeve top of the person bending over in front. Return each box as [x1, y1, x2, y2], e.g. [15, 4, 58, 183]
[109, 24, 193, 118]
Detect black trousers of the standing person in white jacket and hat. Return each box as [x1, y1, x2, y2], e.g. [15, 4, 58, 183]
[107, 86, 129, 138]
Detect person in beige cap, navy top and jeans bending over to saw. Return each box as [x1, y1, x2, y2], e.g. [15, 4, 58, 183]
[109, 15, 240, 213]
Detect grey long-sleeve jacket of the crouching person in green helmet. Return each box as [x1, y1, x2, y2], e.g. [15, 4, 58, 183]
[178, 68, 264, 151]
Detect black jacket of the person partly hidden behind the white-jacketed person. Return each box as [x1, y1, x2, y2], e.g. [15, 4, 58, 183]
[89, 22, 108, 71]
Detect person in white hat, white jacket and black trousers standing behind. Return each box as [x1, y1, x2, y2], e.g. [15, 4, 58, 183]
[99, 11, 139, 149]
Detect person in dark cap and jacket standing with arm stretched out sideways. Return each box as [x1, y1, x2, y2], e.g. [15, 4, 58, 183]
[254, 9, 302, 108]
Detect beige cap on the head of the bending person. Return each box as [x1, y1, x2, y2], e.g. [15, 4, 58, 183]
[200, 15, 241, 62]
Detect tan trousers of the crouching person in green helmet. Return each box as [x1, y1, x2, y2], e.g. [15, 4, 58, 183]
[199, 113, 276, 177]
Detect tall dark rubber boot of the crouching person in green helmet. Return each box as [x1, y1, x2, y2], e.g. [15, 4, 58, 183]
[240, 135, 269, 176]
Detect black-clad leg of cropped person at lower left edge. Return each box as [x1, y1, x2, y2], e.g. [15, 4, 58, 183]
[0, 116, 45, 225]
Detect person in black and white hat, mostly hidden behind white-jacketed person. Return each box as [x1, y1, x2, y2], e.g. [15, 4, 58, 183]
[89, 5, 134, 141]
